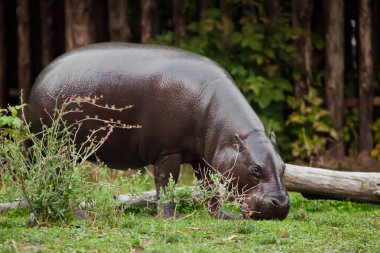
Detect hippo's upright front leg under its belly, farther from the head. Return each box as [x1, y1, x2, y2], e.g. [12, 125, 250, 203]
[154, 154, 181, 218]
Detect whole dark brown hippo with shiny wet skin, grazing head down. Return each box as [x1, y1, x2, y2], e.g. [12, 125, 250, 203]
[28, 43, 290, 219]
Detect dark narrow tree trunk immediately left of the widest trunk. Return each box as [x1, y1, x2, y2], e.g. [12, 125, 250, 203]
[40, 0, 57, 68]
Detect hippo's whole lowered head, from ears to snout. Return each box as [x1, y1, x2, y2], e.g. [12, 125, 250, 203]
[217, 131, 290, 219]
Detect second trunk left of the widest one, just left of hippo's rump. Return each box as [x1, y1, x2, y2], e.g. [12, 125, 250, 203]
[16, 0, 32, 102]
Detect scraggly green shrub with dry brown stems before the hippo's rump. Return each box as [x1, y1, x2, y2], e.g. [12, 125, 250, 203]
[0, 97, 138, 224]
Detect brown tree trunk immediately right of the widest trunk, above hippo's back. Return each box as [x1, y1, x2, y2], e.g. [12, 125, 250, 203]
[108, 0, 132, 41]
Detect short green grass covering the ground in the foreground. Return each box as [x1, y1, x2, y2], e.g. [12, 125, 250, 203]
[0, 193, 380, 252]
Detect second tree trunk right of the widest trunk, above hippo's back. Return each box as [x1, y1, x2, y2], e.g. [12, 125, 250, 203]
[140, 0, 158, 43]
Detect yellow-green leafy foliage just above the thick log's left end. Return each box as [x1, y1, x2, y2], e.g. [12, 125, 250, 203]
[286, 89, 338, 159]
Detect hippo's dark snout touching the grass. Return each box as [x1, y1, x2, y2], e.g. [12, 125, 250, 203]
[242, 195, 290, 220]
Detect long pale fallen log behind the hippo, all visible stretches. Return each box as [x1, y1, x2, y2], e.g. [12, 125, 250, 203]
[0, 164, 380, 213]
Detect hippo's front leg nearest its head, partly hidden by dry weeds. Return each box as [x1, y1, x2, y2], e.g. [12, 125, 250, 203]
[192, 161, 243, 220]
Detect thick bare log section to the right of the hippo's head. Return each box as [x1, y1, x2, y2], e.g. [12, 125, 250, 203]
[283, 164, 380, 204]
